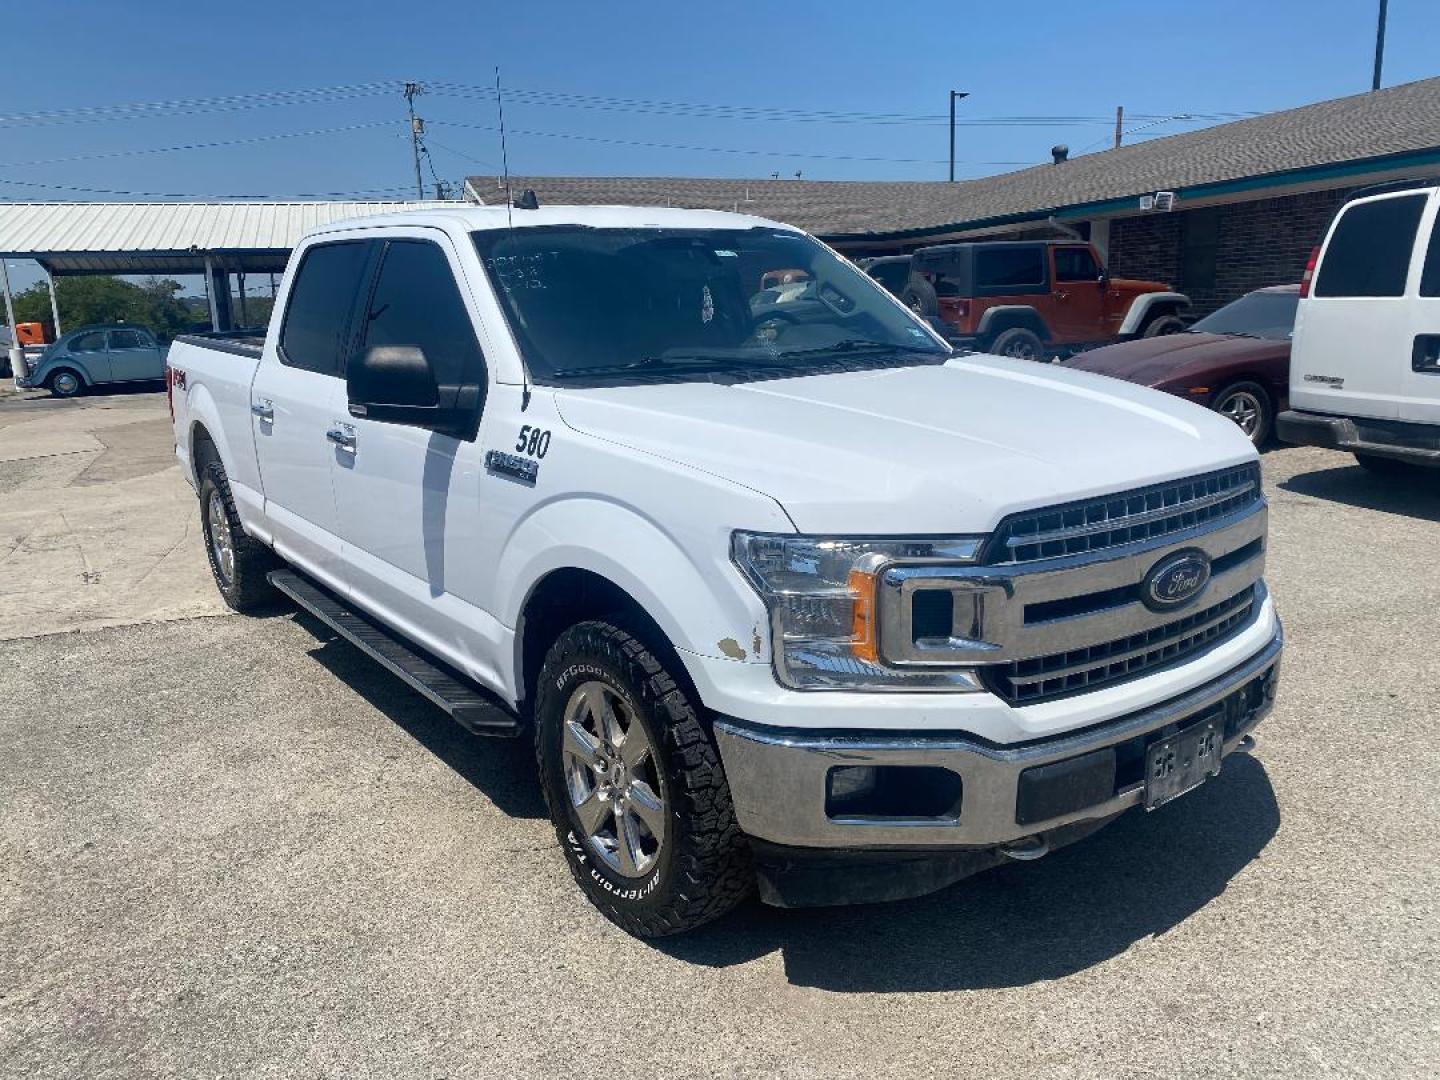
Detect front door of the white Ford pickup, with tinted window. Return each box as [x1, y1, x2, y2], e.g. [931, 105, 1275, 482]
[331, 232, 494, 671]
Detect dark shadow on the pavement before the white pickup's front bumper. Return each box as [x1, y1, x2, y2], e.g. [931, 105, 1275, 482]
[657, 755, 1280, 994]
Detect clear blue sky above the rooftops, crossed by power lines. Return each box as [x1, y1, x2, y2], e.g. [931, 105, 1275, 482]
[0, 0, 1440, 292]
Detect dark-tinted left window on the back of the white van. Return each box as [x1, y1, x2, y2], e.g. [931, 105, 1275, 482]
[1315, 194, 1427, 297]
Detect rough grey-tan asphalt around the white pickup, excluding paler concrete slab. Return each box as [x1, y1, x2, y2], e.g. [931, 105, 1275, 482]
[0, 403, 1440, 1077]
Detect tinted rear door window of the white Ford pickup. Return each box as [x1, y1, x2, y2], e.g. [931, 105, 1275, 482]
[279, 240, 369, 377]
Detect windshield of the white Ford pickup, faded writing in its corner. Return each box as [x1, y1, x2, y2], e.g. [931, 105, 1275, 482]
[474, 225, 950, 382]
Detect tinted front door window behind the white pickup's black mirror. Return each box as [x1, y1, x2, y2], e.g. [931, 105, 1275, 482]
[363, 240, 485, 386]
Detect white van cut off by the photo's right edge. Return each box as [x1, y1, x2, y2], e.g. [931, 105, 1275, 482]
[1277, 179, 1440, 471]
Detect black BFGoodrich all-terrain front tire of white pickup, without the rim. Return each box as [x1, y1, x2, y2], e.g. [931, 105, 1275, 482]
[534, 619, 755, 937]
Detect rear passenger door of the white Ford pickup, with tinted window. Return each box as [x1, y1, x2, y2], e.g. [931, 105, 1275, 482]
[251, 240, 374, 589]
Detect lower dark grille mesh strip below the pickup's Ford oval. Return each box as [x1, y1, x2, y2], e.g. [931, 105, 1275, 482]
[985, 586, 1256, 706]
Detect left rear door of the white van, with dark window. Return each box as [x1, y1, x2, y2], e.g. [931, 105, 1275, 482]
[1290, 192, 1430, 419]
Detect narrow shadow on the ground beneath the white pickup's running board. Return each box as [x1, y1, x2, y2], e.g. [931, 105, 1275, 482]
[287, 609, 549, 818]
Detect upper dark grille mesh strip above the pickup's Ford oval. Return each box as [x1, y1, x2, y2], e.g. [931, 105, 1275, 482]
[985, 464, 1261, 564]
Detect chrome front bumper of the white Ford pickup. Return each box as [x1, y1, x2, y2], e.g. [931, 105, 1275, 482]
[714, 631, 1283, 848]
